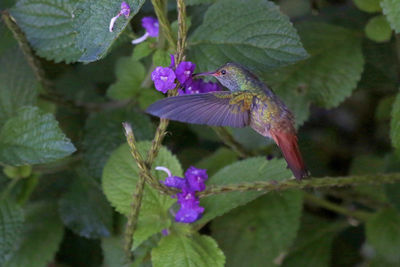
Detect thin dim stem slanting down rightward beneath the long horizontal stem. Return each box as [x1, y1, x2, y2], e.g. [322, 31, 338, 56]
[304, 193, 370, 222]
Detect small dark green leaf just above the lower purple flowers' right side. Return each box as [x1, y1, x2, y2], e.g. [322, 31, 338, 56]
[195, 147, 238, 176]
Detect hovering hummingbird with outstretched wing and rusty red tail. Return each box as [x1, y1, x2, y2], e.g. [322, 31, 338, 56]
[147, 63, 308, 180]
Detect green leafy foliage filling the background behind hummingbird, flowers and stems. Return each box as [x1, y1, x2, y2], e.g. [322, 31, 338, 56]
[0, 0, 400, 267]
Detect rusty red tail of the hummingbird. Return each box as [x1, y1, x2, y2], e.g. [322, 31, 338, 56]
[270, 131, 309, 180]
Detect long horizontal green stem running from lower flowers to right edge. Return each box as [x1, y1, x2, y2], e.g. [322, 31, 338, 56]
[198, 173, 400, 197]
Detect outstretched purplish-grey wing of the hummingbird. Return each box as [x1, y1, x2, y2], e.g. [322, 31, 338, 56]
[146, 91, 254, 128]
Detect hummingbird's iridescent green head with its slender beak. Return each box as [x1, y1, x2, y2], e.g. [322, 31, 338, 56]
[197, 63, 258, 91]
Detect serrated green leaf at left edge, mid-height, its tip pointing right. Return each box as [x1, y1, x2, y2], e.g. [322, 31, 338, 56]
[0, 107, 76, 166]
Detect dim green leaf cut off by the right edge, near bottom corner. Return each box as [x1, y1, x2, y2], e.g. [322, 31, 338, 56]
[366, 208, 400, 262]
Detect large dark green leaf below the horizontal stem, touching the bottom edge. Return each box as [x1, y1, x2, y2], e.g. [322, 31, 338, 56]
[211, 190, 302, 266]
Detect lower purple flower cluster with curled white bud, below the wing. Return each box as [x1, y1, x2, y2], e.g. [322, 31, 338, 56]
[156, 166, 208, 223]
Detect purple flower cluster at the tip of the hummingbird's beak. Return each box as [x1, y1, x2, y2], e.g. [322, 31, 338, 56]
[151, 56, 222, 95]
